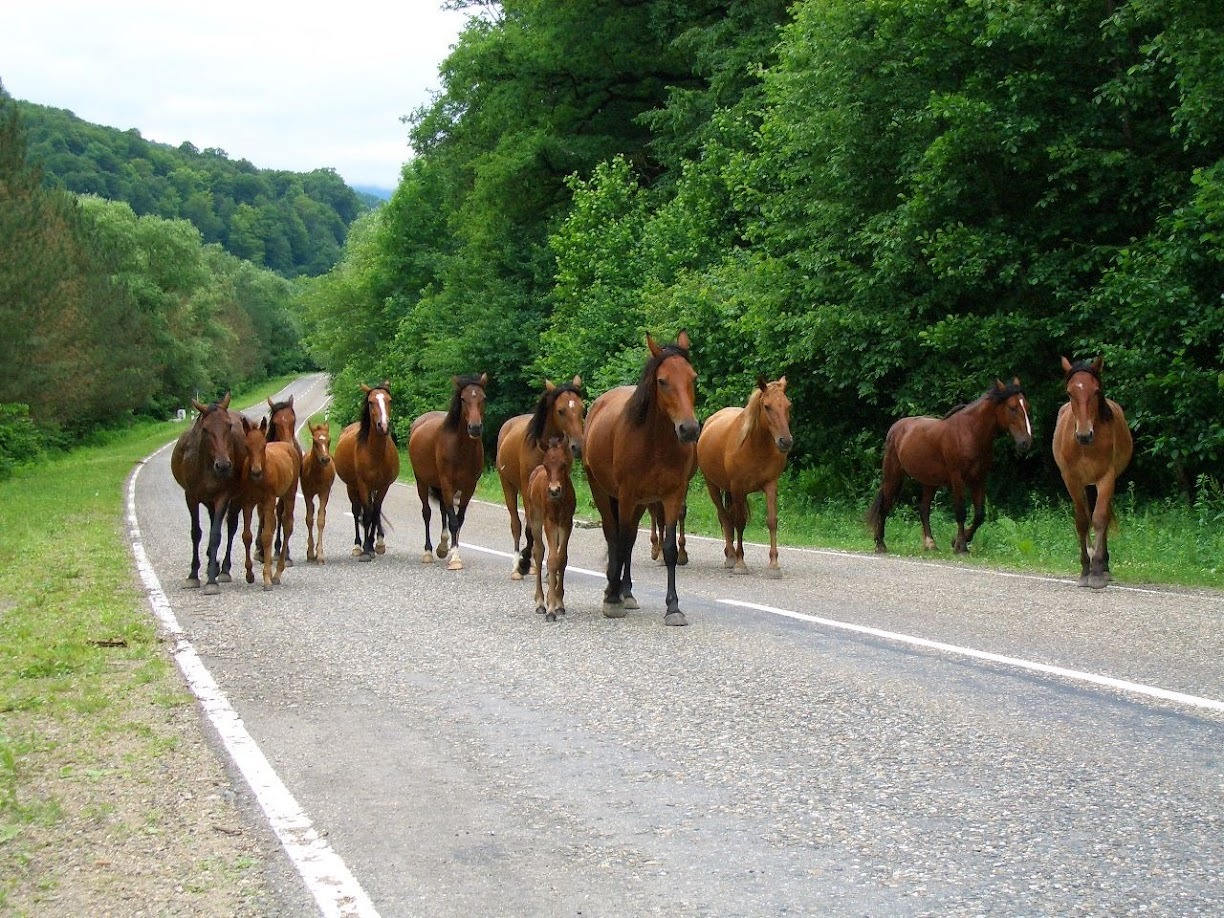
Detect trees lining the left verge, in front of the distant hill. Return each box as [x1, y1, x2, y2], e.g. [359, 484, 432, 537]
[0, 87, 307, 475]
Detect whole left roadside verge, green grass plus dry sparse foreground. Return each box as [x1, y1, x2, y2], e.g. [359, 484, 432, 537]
[0, 381, 293, 913]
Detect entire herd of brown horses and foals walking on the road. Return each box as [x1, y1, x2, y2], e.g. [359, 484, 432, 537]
[171, 332, 1133, 625]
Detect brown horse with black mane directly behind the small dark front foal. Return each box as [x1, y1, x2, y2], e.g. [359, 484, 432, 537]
[494, 376, 586, 580]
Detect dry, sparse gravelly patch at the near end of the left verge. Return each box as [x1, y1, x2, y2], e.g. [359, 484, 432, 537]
[0, 655, 298, 918]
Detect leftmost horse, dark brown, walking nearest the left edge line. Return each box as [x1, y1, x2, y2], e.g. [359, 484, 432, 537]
[170, 392, 246, 595]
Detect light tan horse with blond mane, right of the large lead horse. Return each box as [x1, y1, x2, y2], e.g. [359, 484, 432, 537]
[696, 376, 794, 574]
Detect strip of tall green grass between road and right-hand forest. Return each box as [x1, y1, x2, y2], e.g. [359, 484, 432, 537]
[479, 469, 1224, 589]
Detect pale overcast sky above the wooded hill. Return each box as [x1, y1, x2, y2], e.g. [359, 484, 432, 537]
[0, 0, 466, 188]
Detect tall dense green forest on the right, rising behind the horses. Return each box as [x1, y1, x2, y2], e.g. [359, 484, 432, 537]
[300, 0, 1224, 511]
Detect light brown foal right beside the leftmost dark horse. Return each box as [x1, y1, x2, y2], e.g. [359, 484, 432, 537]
[239, 417, 299, 590]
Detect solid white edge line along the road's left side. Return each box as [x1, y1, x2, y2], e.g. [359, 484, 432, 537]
[127, 443, 378, 918]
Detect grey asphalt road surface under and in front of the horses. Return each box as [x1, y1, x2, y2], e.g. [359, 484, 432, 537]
[129, 378, 1224, 918]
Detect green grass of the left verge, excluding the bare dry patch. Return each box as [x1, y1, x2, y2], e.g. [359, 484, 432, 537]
[0, 379, 286, 908]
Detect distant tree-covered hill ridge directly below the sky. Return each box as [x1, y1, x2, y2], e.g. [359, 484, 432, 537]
[17, 102, 370, 277]
